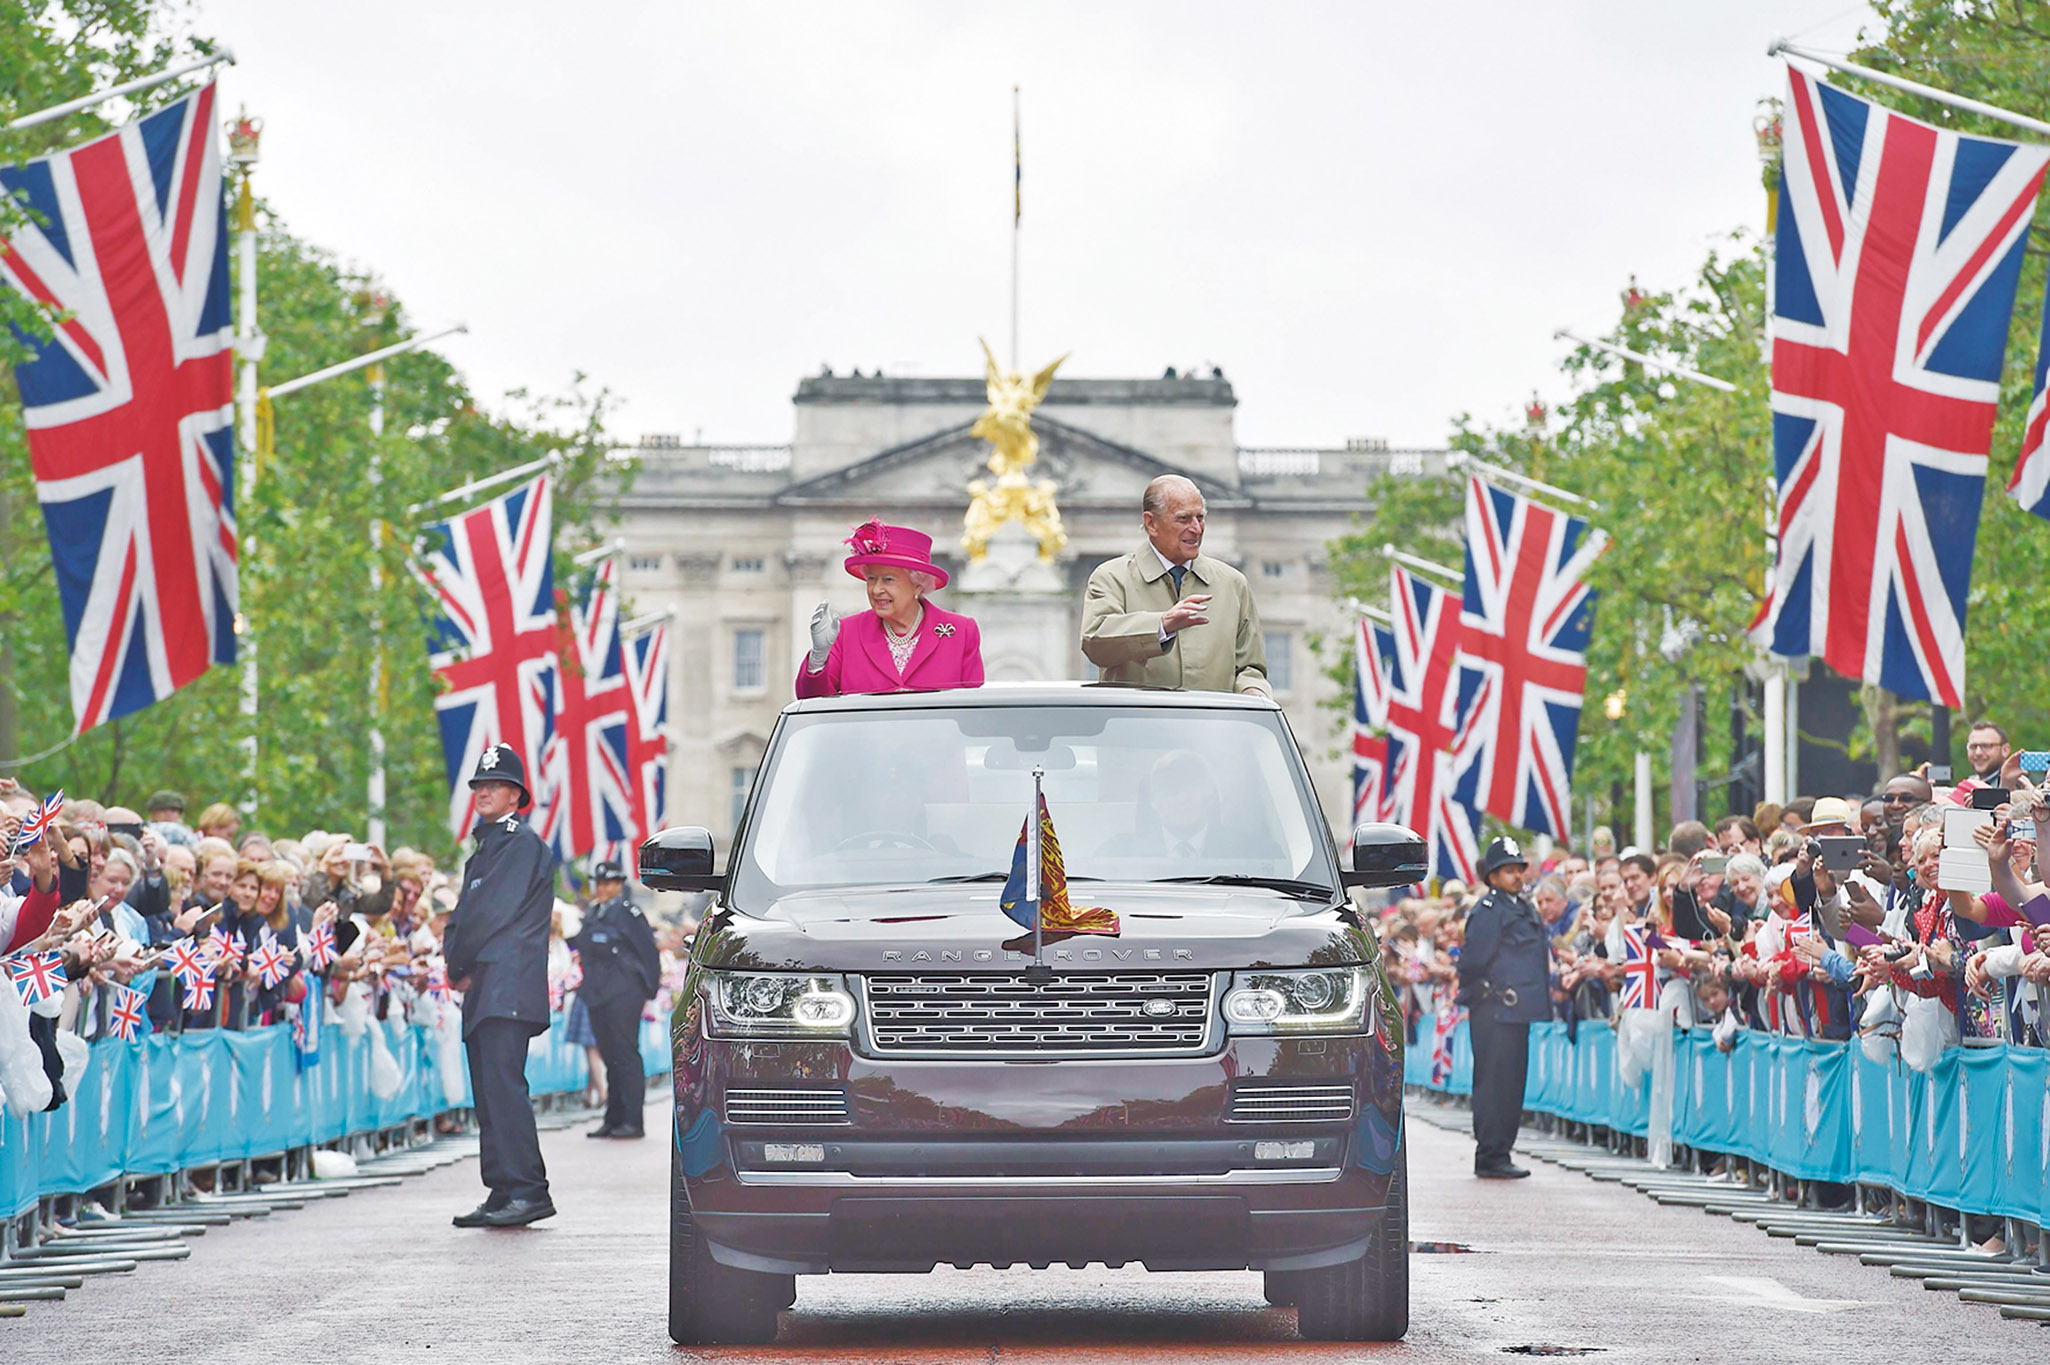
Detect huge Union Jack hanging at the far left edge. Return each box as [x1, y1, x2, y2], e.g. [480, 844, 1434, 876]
[0, 84, 238, 734]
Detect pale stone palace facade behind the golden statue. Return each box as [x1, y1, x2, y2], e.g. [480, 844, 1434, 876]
[598, 373, 1445, 840]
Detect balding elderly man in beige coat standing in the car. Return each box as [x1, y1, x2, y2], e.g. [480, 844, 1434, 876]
[1082, 473, 1269, 697]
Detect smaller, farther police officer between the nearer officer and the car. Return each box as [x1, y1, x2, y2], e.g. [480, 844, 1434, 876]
[570, 859, 662, 1138]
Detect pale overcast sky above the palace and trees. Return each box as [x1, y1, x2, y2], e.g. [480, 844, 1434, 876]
[197, 0, 1868, 445]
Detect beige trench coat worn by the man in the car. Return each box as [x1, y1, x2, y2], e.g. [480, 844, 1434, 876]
[1082, 545, 1273, 693]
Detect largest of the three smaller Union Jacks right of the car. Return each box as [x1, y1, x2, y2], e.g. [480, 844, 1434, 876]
[1458, 475, 1607, 838]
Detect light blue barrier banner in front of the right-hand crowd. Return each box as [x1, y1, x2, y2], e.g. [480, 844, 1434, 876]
[1404, 1019, 2050, 1226]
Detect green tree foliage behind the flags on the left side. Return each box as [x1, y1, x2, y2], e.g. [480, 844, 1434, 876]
[0, 2, 629, 851]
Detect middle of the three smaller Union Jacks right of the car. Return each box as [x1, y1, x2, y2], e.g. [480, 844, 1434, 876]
[1382, 568, 1480, 885]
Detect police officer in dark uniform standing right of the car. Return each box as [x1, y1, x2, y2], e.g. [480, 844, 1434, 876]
[1460, 836, 1552, 1181]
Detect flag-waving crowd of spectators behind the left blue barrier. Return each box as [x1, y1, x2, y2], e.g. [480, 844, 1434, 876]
[0, 779, 685, 1115]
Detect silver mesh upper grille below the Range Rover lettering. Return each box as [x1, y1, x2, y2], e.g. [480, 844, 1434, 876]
[863, 971, 1214, 1058]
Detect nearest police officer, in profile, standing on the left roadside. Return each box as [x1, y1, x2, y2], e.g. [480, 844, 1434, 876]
[441, 744, 556, 1228]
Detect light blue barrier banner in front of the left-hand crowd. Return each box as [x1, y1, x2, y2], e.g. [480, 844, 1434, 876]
[0, 1015, 668, 1217]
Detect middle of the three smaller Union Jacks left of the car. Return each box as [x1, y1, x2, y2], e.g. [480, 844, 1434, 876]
[533, 557, 636, 859]
